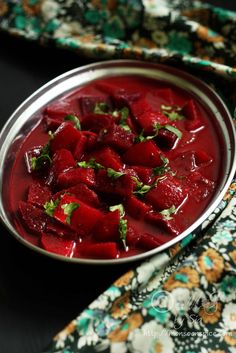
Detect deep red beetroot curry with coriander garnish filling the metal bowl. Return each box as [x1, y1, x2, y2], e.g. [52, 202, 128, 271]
[10, 76, 219, 259]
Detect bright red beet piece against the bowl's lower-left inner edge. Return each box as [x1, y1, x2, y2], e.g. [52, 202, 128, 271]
[41, 233, 75, 257]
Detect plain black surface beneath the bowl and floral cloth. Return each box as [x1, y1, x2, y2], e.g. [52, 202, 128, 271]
[0, 0, 236, 353]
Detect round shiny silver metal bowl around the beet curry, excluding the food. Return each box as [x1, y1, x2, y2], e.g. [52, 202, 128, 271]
[0, 60, 236, 264]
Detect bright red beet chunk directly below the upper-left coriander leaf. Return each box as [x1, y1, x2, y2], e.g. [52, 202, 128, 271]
[50, 122, 81, 153]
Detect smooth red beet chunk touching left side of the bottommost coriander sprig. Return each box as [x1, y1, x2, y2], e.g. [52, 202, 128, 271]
[94, 210, 120, 242]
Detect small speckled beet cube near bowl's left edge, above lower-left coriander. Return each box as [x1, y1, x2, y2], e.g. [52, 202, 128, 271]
[27, 182, 52, 207]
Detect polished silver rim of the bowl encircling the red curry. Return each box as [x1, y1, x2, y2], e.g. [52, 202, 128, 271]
[0, 60, 236, 265]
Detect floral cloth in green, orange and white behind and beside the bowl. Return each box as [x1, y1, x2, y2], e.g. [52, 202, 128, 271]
[0, 0, 236, 353]
